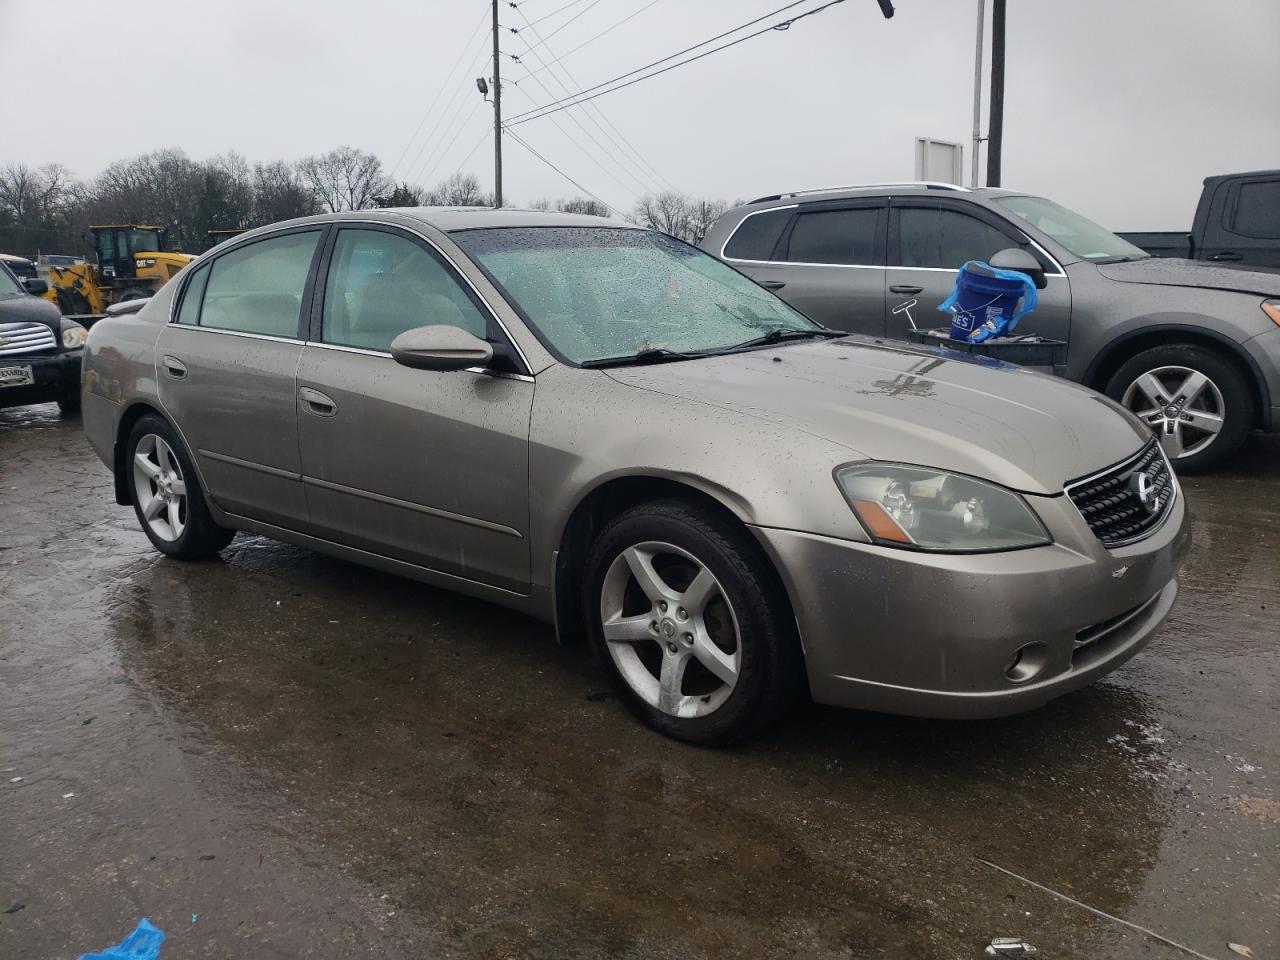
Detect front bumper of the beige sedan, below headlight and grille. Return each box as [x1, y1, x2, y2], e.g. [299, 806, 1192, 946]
[753, 492, 1190, 718]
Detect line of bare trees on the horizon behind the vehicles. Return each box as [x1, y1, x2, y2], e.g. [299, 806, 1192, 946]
[0, 146, 730, 257]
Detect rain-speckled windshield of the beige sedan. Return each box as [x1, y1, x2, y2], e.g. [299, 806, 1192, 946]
[453, 227, 822, 364]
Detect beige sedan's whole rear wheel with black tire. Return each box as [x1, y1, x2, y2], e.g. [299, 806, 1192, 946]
[124, 413, 236, 559]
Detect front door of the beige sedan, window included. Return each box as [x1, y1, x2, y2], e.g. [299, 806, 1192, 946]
[297, 225, 534, 593]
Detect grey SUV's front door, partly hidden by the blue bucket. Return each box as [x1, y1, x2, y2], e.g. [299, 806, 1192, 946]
[886, 197, 1071, 340]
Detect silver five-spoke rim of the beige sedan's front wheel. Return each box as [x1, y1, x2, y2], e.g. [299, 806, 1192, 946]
[600, 541, 742, 717]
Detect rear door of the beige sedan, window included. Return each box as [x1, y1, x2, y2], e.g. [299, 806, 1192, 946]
[156, 229, 323, 529]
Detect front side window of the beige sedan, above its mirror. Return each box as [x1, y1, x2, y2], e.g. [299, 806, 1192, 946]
[320, 229, 489, 351]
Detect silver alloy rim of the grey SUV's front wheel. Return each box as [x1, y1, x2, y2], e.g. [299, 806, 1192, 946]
[1120, 366, 1226, 460]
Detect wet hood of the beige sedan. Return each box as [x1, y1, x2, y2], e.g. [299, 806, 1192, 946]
[608, 338, 1151, 494]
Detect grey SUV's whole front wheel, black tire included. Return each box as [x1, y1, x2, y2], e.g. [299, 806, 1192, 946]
[1106, 343, 1253, 474]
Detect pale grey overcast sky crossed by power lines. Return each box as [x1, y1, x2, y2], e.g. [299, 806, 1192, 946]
[0, 0, 1280, 230]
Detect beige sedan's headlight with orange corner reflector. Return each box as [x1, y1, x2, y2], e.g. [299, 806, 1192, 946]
[836, 463, 1053, 553]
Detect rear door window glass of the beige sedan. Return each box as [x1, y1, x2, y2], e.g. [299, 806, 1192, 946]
[199, 230, 320, 338]
